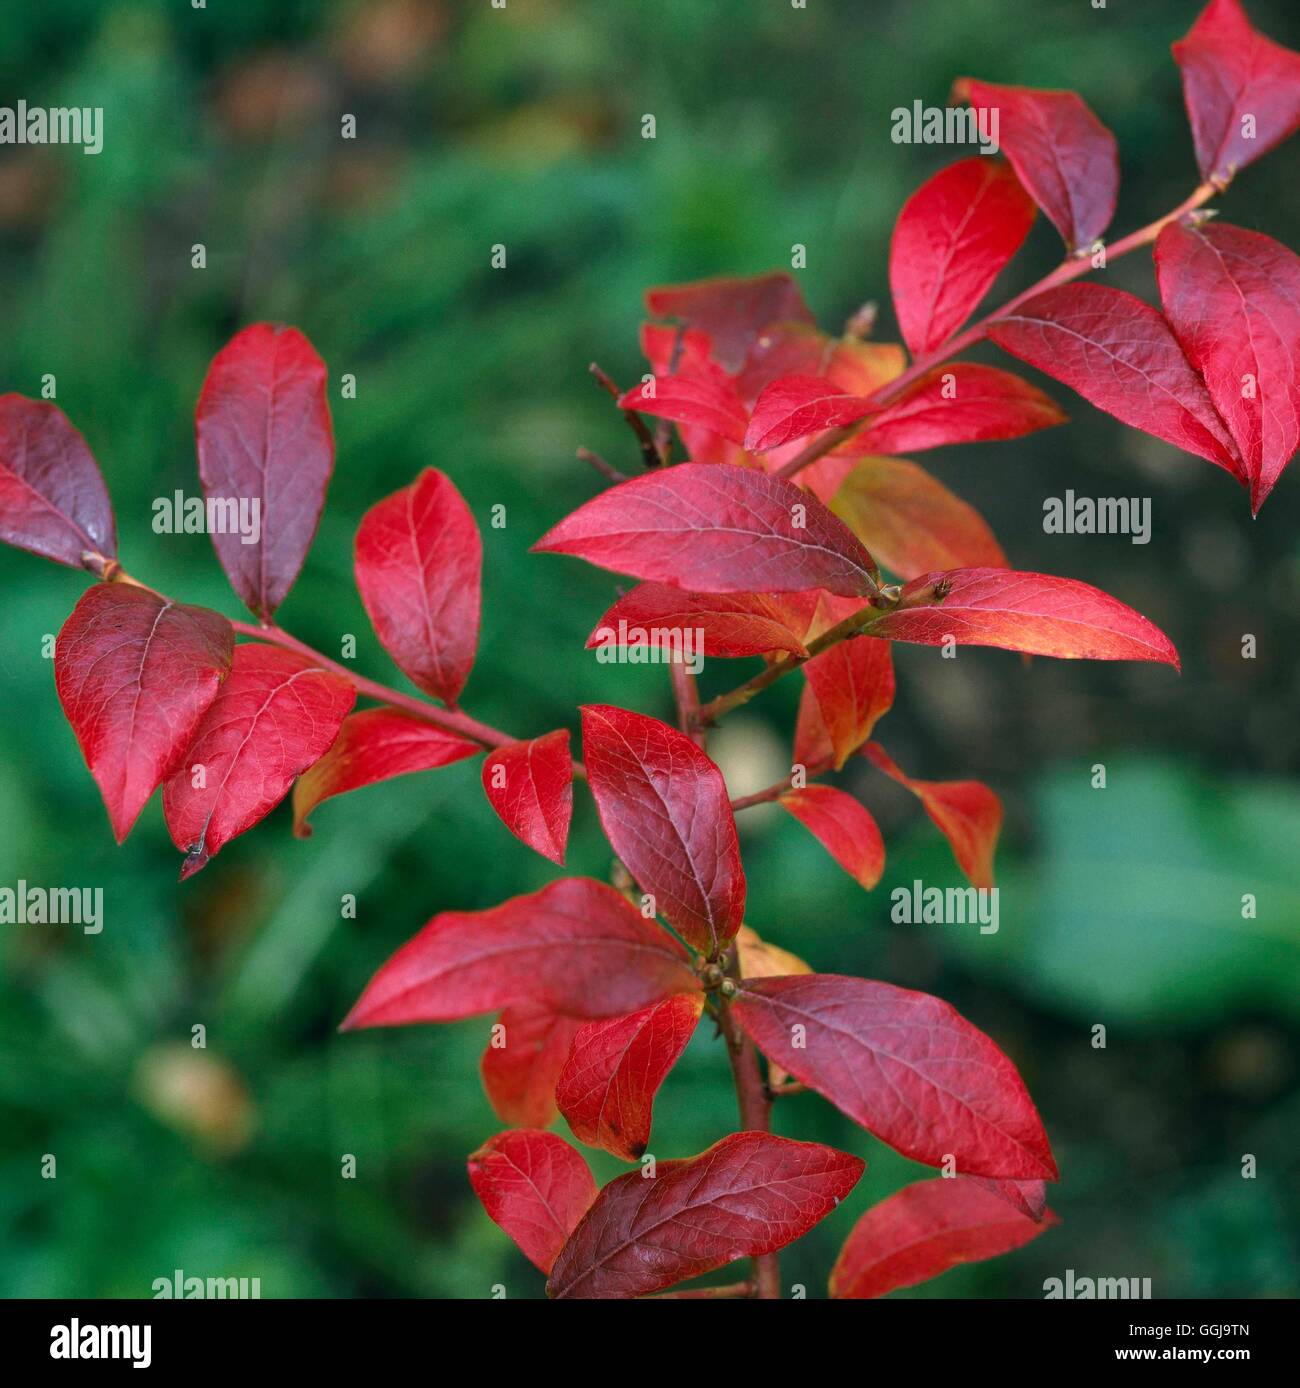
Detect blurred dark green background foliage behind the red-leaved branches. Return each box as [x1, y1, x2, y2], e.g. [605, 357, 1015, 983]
[0, 0, 1300, 1296]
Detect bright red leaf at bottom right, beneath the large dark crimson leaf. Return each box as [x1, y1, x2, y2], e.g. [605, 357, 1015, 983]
[831, 1177, 1056, 1299]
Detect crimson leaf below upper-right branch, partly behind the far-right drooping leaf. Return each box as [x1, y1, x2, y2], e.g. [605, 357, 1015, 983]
[989, 285, 1242, 476]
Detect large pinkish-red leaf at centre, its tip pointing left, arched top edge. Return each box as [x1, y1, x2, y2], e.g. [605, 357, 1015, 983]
[533, 462, 874, 597]
